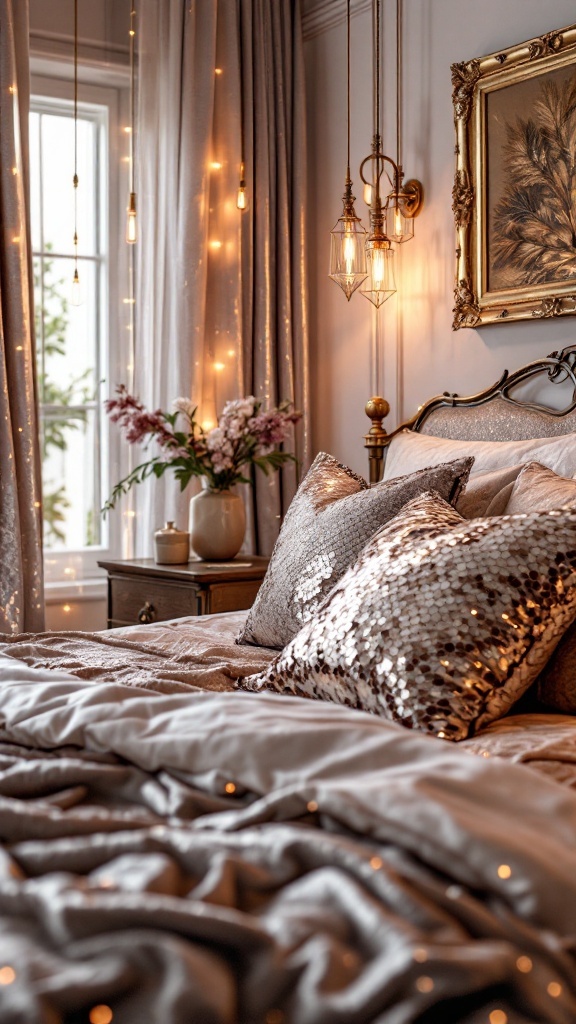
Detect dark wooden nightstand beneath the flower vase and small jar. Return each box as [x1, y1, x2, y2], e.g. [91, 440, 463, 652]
[98, 555, 269, 630]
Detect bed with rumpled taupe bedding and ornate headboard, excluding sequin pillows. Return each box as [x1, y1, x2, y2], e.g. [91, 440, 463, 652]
[0, 346, 576, 1024]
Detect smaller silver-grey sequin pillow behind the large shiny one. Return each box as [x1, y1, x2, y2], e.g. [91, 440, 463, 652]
[237, 452, 474, 647]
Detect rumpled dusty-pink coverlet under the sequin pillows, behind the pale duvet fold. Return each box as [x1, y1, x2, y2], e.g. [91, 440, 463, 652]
[0, 611, 576, 788]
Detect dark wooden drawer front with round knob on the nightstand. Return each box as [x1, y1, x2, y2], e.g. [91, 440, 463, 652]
[110, 575, 201, 626]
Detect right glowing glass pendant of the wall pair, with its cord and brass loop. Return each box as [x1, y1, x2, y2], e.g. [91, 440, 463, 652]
[360, 0, 396, 308]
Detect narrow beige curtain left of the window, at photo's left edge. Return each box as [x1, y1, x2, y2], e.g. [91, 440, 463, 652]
[0, 0, 44, 633]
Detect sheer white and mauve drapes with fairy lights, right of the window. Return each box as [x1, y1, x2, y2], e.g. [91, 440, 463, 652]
[134, 0, 308, 554]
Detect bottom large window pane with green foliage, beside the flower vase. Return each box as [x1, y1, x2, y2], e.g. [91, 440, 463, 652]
[42, 409, 102, 551]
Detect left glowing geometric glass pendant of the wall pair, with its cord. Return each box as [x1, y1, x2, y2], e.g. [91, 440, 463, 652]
[329, 0, 367, 302]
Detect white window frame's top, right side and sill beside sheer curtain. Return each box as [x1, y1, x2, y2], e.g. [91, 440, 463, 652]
[31, 68, 133, 596]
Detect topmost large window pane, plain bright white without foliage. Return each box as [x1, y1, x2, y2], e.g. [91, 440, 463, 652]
[40, 114, 97, 256]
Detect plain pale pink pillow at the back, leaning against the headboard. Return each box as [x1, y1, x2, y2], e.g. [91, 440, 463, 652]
[384, 430, 576, 480]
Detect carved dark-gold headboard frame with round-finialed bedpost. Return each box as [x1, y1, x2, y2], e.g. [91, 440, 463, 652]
[364, 345, 576, 483]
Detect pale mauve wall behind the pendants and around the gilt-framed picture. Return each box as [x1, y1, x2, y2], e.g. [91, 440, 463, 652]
[304, 0, 576, 472]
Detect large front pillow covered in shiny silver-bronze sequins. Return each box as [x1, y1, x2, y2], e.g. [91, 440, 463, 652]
[242, 495, 576, 739]
